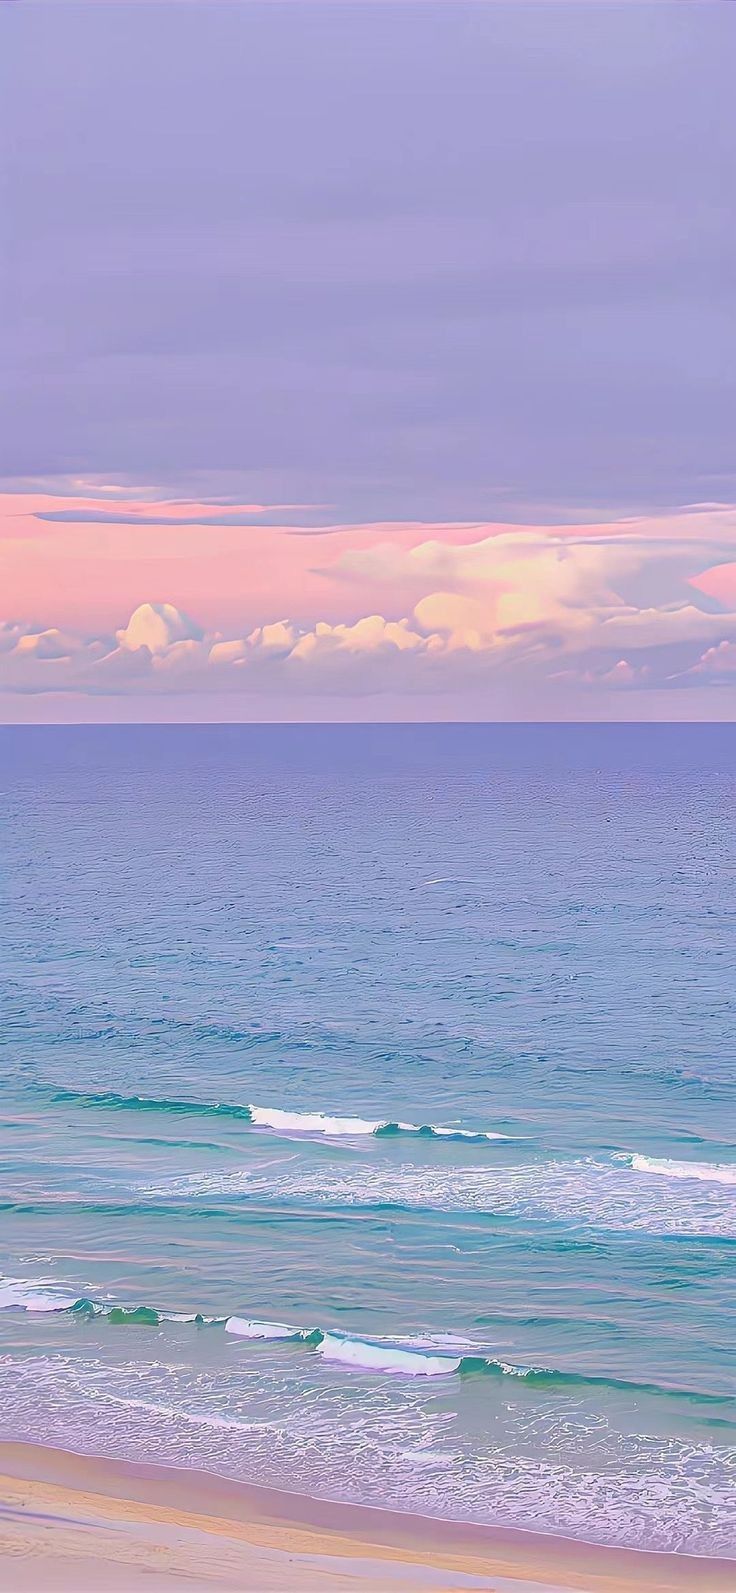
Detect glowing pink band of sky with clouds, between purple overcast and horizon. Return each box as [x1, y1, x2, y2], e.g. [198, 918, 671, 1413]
[0, 487, 736, 718]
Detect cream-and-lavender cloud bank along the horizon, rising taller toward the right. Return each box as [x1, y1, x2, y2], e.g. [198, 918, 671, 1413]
[0, 505, 736, 717]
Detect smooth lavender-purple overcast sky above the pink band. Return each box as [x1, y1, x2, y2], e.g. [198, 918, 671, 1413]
[0, 0, 736, 723]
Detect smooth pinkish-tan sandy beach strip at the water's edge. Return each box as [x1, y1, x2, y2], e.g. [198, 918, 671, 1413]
[0, 1442, 736, 1593]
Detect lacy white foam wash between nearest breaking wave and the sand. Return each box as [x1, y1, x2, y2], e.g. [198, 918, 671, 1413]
[0, 1352, 736, 1561]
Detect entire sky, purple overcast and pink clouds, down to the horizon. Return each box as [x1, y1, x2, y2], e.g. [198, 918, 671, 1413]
[0, 0, 736, 722]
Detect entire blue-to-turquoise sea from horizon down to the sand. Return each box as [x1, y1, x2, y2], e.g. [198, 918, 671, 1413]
[0, 726, 736, 1553]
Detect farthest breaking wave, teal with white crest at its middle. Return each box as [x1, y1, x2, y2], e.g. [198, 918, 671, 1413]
[44, 1090, 508, 1141]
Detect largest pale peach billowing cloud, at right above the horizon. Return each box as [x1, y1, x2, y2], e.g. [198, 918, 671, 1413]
[338, 507, 736, 655]
